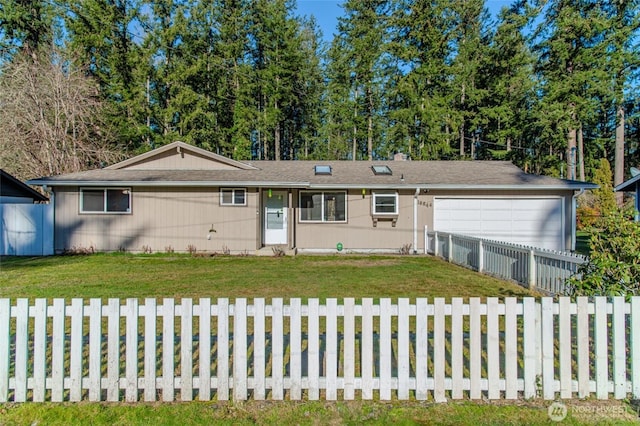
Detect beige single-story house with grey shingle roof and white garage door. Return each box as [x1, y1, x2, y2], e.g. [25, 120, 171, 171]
[30, 142, 596, 254]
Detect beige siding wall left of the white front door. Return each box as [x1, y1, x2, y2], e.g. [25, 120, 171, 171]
[55, 187, 258, 252]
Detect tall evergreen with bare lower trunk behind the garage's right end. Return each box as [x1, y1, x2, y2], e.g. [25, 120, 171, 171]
[536, 0, 608, 179]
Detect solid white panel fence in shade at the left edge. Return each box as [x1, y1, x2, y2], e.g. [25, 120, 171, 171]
[0, 204, 53, 256]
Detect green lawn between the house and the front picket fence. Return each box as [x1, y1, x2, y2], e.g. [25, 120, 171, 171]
[0, 253, 532, 300]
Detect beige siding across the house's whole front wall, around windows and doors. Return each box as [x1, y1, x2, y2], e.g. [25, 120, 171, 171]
[55, 187, 572, 253]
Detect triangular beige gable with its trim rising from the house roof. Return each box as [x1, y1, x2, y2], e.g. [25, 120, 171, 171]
[105, 141, 252, 170]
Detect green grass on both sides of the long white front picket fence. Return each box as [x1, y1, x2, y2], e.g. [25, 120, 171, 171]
[8, 253, 637, 425]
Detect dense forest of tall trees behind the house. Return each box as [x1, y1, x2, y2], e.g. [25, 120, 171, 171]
[0, 0, 640, 194]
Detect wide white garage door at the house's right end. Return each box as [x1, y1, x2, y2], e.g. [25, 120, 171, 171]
[433, 198, 565, 250]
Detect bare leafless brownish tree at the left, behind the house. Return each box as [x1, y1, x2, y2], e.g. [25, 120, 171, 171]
[0, 49, 121, 179]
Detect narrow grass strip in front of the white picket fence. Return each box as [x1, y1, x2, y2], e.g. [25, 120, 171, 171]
[0, 401, 637, 426]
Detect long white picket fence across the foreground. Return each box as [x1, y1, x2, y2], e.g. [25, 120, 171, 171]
[0, 297, 640, 402]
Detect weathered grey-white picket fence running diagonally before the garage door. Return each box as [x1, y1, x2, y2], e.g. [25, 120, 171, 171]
[425, 231, 587, 295]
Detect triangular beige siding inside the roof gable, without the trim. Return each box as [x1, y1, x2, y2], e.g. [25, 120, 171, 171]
[127, 149, 237, 170]
